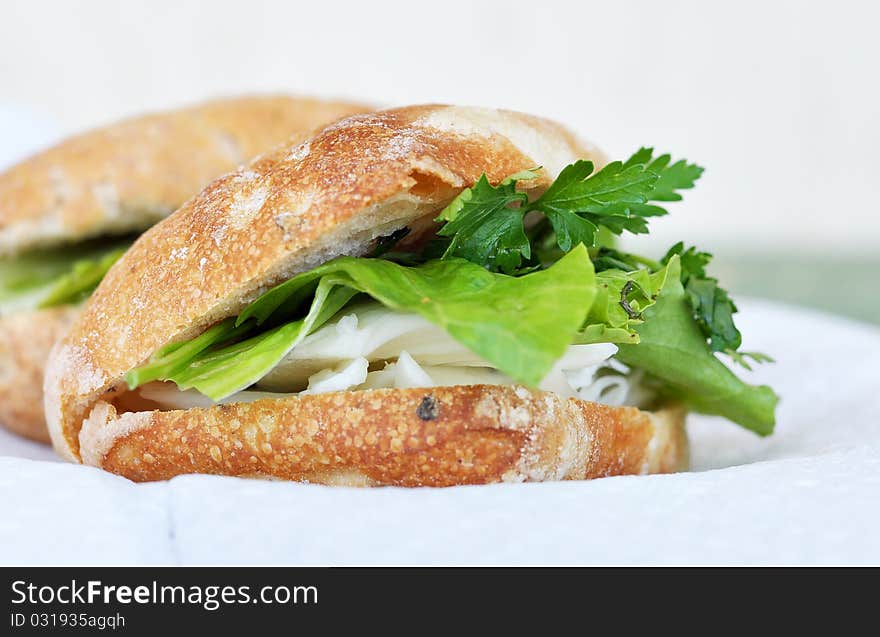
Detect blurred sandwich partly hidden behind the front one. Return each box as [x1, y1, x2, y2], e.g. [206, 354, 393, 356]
[0, 96, 365, 442]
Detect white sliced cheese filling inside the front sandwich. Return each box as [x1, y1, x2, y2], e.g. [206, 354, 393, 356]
[140, 302, 639, 409]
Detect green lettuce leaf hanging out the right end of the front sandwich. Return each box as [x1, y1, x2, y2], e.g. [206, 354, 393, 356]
[617, 255, 778, 436]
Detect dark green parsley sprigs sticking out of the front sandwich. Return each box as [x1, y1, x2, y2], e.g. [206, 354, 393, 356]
[426, 147, 766, 368]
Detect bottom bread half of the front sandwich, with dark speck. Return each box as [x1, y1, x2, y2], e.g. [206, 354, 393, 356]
[80, 385, 687, 487]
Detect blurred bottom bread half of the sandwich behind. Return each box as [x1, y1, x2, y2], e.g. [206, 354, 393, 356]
[0, 306, 79, 442]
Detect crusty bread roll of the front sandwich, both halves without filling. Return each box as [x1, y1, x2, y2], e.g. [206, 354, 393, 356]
[45, 106, 686, 485]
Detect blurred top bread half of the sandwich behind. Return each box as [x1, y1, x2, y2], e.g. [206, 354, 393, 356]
[0, 96, 369, 255]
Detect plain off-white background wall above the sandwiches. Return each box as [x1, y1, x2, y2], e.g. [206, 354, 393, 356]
[0, 0, 880, 255]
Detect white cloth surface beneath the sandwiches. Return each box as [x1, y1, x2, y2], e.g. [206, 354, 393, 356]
[0, 301, 880, 564]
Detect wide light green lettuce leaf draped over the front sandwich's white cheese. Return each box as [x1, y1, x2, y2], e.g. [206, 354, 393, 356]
[127, 246, 596, 400]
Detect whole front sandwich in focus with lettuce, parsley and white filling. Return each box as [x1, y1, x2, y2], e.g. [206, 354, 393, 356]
[45, 105, 776, 486]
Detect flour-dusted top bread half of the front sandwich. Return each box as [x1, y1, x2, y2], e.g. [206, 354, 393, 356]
[46, 106, 601, 460]
